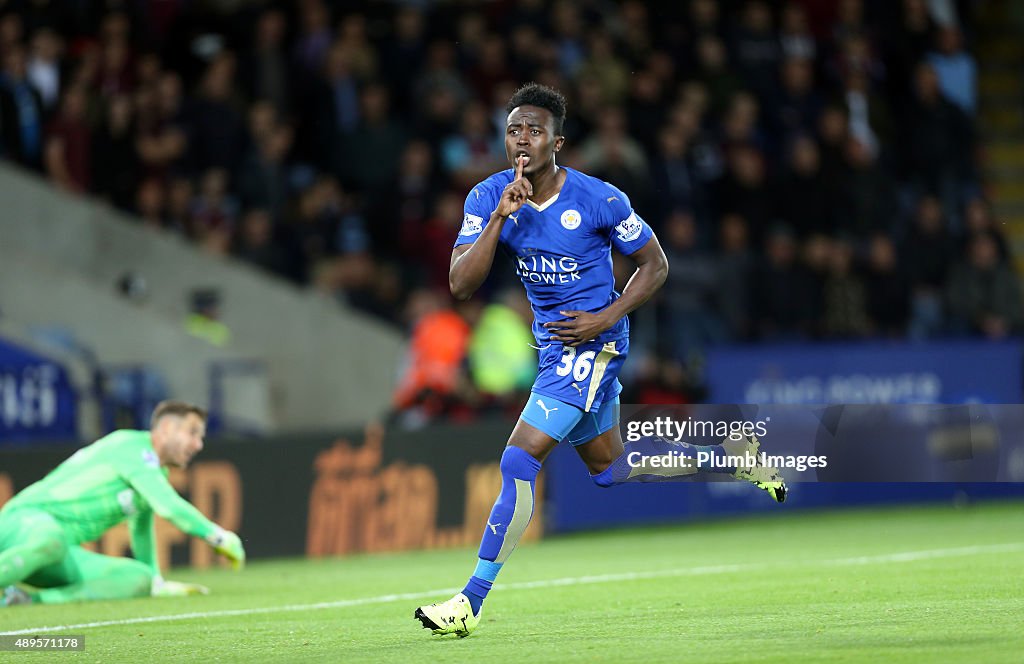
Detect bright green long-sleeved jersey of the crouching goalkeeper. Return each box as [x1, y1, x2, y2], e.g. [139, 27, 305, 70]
[0, 429, 219, 570]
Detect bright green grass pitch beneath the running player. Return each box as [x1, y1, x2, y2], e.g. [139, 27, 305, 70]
[0, 502, 1024, 664]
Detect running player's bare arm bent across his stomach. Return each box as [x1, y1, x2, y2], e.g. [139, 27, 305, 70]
[544, 236, 669, 346]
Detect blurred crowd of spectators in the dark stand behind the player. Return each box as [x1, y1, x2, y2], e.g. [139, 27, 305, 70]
[0, 0, 1011, 413]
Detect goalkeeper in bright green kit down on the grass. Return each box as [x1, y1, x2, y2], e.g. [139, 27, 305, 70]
[0, 401, 246, 606]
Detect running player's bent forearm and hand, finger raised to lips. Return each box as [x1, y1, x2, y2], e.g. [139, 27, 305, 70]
[449, 157, 534, 300]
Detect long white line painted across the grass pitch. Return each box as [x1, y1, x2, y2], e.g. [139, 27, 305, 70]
[0, 542, 1024, 636]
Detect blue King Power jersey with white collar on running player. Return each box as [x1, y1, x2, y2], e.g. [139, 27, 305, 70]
[455, 167, 652, 346]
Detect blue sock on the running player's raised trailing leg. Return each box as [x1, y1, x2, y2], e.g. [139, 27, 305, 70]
[591, 437, 736, 487]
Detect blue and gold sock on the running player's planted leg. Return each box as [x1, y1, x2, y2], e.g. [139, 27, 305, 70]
[463, 446, 541, 614]
